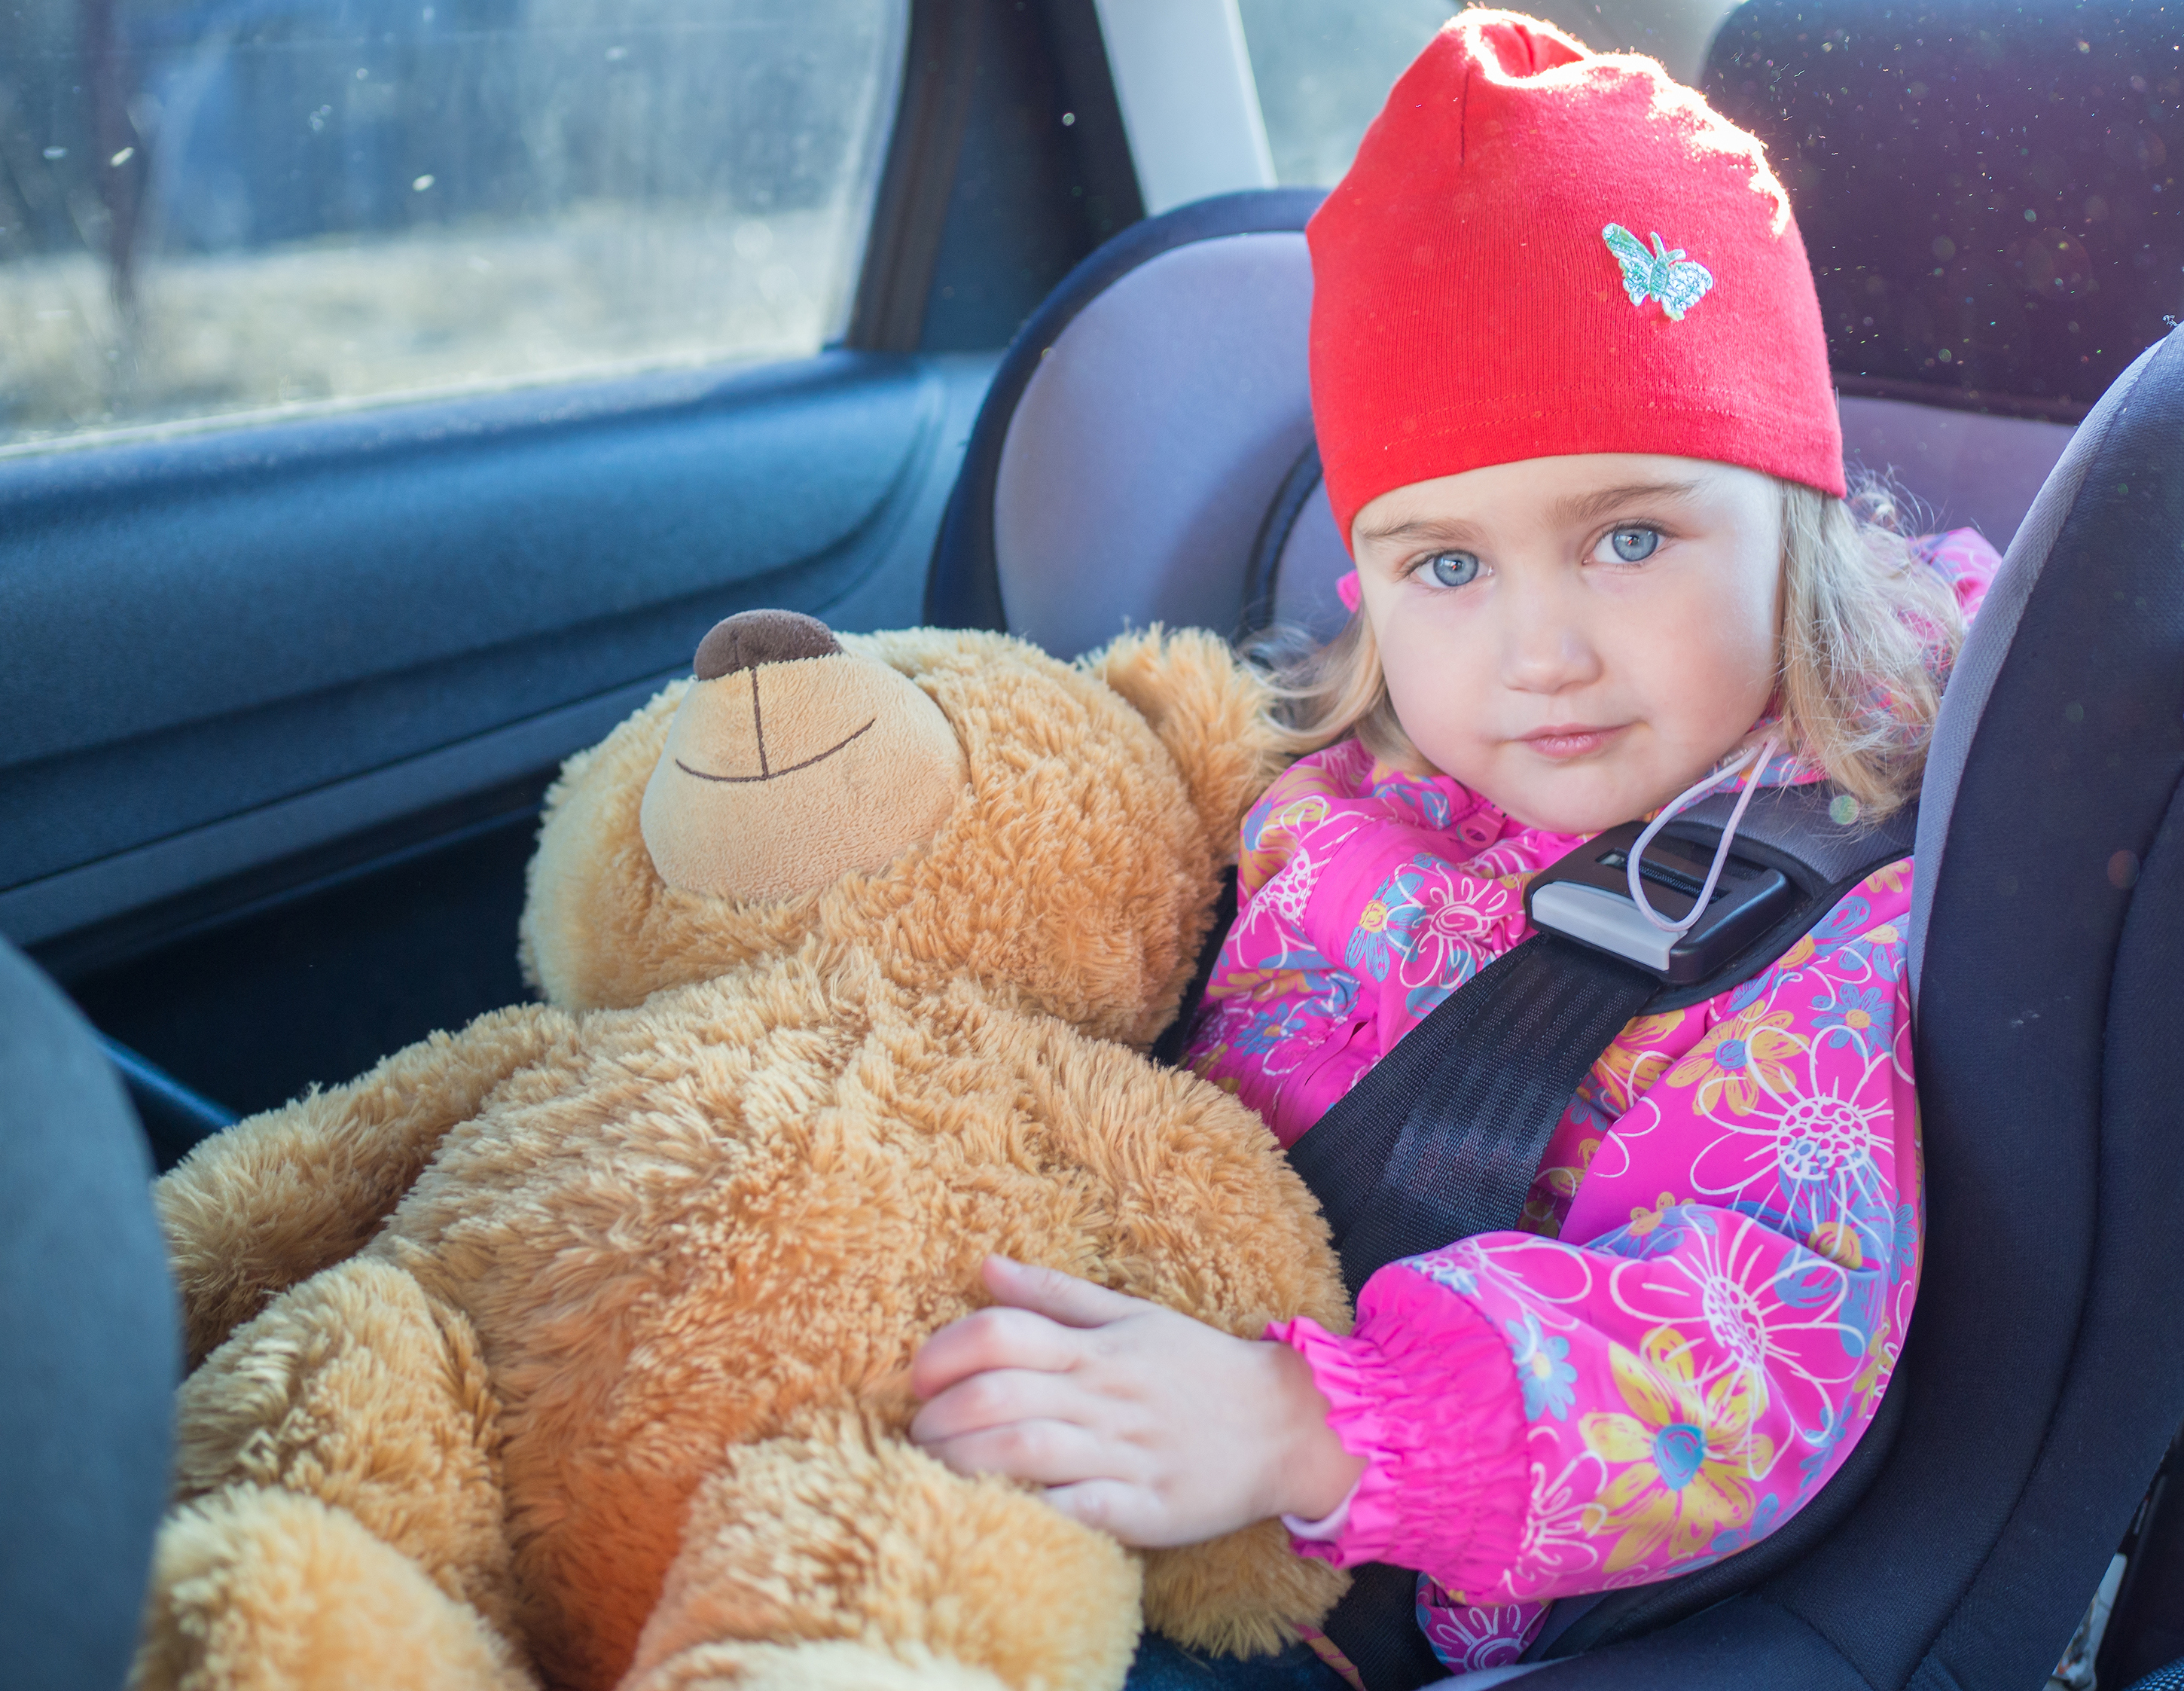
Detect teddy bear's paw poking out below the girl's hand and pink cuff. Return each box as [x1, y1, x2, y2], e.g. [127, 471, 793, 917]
[1145, 1521, 1350, 1656]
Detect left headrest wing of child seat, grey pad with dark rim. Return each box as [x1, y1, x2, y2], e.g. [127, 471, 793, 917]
[926, 188, 1319, 658]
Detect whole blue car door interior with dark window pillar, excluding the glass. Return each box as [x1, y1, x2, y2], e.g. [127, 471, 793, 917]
[0, 0, 1140, 1162]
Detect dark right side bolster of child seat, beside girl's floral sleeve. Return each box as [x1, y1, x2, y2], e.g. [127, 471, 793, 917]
[1493, 337, 2184, 1691]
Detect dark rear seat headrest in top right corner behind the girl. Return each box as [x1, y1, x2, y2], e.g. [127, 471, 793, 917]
[1704, 0, 2184, 417]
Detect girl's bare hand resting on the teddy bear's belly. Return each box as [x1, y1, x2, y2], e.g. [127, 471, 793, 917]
[911, 1256, 1365, 1547]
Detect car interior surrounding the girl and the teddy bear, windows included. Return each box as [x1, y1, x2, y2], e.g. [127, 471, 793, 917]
[0, 0, 2184, 1691]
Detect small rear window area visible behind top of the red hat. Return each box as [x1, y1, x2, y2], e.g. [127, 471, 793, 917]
[1238, 0, 1734, 188]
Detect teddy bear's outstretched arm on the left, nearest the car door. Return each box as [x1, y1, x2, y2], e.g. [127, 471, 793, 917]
[153, 1005, 575, 1368]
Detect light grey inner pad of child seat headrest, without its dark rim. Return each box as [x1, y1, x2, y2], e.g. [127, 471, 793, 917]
[994, 231, 1313, 658]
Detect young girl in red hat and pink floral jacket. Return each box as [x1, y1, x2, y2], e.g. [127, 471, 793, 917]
[913, 9, 1996, 1686]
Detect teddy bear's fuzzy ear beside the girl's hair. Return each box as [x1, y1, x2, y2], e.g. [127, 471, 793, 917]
[1077, 623, 1289, 863]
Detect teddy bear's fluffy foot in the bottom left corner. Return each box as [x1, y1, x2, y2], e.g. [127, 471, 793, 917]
[129, 1485, 535, 1691]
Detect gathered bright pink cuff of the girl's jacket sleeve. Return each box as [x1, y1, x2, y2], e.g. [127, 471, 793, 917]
[1267, 1262, 1531, 1601]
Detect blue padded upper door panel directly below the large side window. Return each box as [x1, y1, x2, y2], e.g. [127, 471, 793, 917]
[0, 354, 987, 944]
